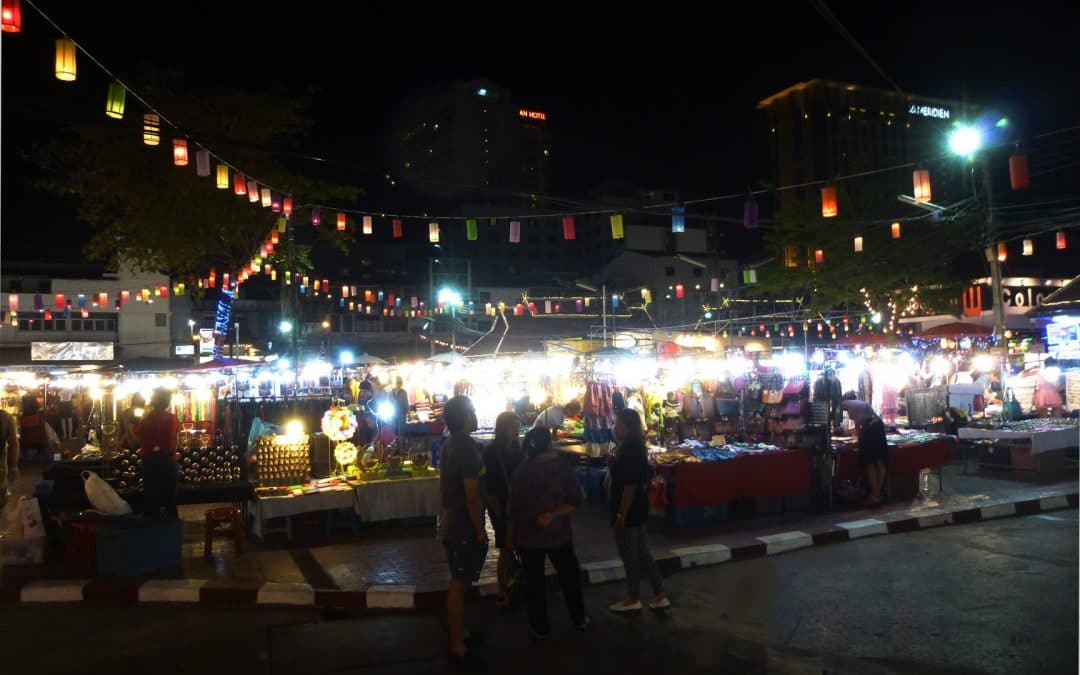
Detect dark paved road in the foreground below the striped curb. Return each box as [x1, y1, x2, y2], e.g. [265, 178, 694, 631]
[0, 510, 1080, 675]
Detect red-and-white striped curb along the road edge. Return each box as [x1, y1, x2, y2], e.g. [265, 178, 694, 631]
[0, 492, 1080, 610]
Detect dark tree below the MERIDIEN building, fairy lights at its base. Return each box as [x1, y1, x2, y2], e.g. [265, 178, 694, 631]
[751, 179, 981, 321]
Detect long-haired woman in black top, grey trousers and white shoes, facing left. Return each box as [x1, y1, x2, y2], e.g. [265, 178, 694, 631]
[609, 408, 671, 613]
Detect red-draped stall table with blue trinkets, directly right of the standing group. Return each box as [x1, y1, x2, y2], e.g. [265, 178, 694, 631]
[650, 443, 811, 509]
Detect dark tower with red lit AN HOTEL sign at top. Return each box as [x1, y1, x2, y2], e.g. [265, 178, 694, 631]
[390, 79, 551, 207]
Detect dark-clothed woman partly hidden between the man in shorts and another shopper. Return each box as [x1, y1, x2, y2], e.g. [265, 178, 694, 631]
[484, 413, 523, 607]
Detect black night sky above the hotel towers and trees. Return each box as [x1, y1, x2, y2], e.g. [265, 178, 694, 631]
[0, 0, 1080, 260]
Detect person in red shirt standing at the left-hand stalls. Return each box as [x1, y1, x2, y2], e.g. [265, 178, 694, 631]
[135, 389, 180, 518]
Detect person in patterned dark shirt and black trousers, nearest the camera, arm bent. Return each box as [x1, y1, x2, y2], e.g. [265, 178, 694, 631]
[509, 428, 590, 639]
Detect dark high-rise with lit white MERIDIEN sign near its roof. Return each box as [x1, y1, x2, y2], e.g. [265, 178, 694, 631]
[757, 79, 974, 207]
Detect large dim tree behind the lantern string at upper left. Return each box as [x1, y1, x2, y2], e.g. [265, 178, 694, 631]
[35, 76, 361, 276]
